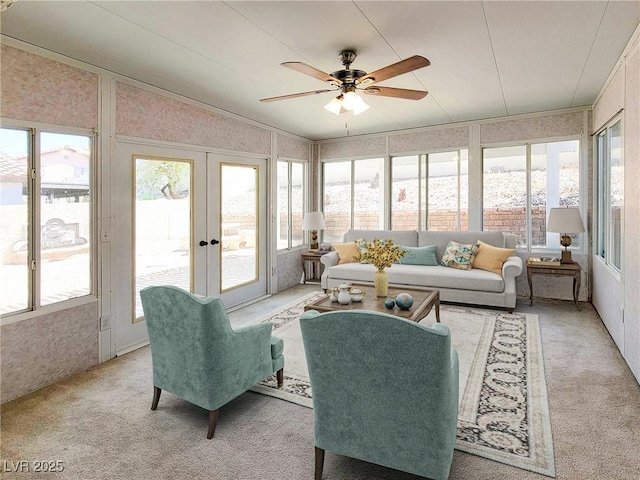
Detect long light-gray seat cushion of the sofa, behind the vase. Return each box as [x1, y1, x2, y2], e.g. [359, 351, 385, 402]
[329, 263, 504, 292]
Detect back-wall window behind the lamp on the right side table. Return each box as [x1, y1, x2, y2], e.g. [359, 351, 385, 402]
[482, 140, 581, 250]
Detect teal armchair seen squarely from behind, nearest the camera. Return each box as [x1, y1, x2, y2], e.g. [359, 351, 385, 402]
[300, 310, 458, 480]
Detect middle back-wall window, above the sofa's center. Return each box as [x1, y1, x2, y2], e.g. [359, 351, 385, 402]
[391, 149, 469, 230]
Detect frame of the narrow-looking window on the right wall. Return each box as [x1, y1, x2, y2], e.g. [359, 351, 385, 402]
[593, 112, 625, 277]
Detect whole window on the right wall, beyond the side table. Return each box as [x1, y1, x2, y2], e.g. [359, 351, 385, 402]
[595, 119, 624, 270]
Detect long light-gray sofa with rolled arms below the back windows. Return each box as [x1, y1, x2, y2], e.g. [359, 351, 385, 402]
[320, 230, 522, 312]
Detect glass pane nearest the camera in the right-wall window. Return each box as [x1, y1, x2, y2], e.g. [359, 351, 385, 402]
[609, 122, 624, 269]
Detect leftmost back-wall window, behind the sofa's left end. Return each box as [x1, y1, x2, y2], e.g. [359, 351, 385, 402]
[322, 158, 384, 242]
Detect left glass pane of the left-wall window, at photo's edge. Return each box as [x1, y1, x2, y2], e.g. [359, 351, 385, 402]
[0, 128, 31, 314]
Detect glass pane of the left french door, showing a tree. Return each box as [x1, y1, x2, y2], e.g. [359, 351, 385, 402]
[133, 158, 188, 319]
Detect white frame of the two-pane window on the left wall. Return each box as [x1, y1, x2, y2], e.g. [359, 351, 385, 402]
[0, 118, 99, 325]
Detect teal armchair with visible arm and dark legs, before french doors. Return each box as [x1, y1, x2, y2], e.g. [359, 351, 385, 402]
[140, 286, 284, 438]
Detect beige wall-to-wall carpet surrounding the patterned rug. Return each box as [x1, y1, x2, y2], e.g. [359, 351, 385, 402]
[0, 284, 640, 480]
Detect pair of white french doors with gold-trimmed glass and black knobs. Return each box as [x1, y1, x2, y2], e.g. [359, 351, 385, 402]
[112, 142, 267, 354]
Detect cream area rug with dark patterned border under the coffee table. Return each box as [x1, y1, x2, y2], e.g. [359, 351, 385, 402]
[252, 293, 555, 477]
